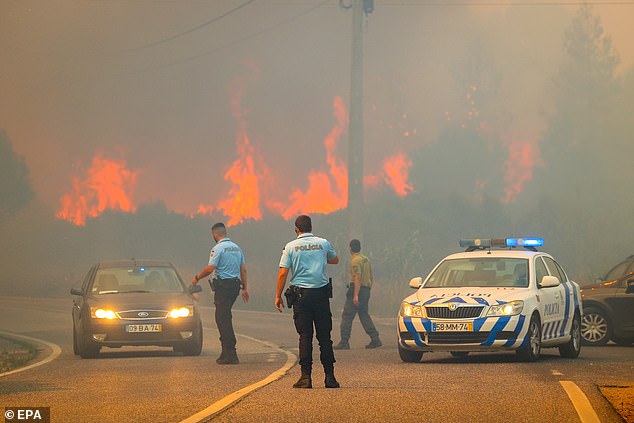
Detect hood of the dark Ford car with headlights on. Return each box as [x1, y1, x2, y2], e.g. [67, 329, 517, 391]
[89, 292, 194, 310]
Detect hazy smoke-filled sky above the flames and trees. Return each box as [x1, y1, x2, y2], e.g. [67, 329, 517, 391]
[0, 0, 634, 222]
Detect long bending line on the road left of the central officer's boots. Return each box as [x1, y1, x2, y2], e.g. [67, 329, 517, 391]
[180, 333, 297, 423]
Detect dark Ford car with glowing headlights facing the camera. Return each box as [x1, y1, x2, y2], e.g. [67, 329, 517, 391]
[70, 260, 203, 358]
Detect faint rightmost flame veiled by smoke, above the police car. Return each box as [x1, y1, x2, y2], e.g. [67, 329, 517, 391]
[502, 140, 543, 204]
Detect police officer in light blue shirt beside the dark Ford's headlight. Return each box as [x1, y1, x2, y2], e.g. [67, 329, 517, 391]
[192, 223, 249, 364]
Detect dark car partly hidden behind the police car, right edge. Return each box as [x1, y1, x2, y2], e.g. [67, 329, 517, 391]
[581, 256, 634, 345]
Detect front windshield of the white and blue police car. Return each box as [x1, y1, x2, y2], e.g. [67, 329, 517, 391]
[423, 257, 528, 288]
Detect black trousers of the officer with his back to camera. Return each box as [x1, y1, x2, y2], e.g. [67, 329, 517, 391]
[293, 285, 335, 373]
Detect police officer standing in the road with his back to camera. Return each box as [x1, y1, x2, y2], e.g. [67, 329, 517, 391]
[275, 215, 339, 388]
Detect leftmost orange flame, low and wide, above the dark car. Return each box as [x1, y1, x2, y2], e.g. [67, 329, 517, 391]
[55, 154, 139, 226]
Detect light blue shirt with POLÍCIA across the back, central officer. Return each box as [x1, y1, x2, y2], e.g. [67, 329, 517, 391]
[280, 232, 337, 288]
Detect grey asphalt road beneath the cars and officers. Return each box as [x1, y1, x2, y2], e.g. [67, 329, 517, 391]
[0, 297, 634, 422]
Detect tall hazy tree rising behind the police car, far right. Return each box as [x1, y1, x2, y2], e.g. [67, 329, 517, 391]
[526, 6, 634, 282]
